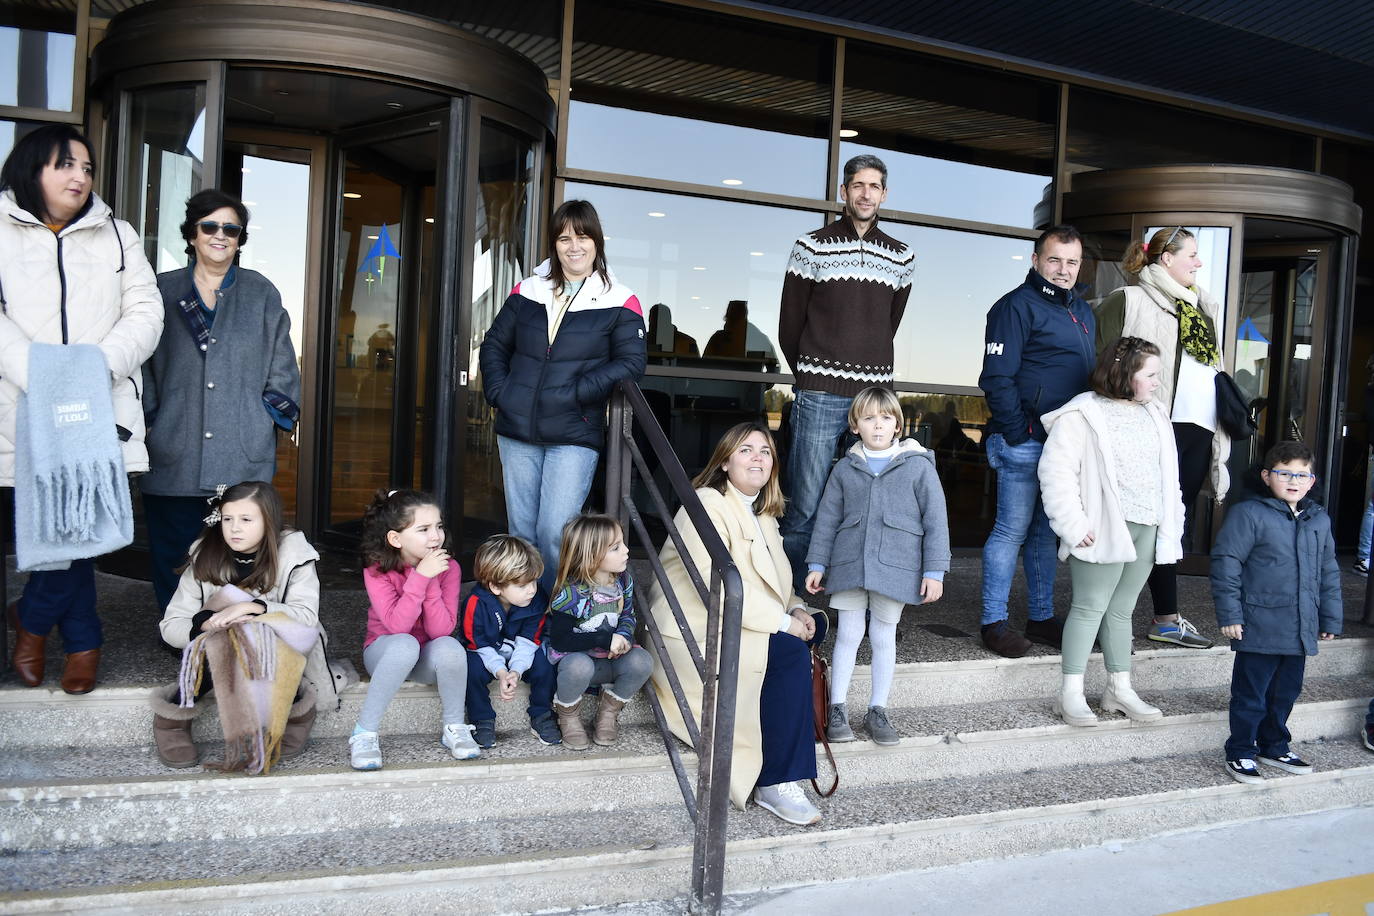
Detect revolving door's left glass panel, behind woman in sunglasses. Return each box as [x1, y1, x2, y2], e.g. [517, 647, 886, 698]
[117, 82, 205, 273]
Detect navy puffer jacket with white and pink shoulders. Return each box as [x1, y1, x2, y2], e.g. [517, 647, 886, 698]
[480, 261, 644, 450]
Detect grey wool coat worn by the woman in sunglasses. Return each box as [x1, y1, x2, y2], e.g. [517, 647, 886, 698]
[139, 268, 301, 496]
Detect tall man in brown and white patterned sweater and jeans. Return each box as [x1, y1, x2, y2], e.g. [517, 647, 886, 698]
[778, 155, 916, 595]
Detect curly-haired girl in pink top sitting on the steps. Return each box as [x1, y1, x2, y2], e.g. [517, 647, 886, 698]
[349, 490, 481, 769]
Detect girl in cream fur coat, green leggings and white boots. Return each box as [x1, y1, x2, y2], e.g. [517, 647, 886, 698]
[1040, 336, 1183, 725]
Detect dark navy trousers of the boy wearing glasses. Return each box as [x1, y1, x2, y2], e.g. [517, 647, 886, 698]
[1226, 652, 1307, 761]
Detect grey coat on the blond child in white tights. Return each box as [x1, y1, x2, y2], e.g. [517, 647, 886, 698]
[807, 439, 949, 604]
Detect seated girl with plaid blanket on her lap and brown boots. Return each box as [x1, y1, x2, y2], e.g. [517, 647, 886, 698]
[153, 481, 328, 773]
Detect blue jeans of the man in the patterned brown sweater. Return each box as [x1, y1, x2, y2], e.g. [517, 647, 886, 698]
[779, 390, 853, 595]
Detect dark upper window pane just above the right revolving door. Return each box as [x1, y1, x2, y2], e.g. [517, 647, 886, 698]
[1065, 88, 1314, 172]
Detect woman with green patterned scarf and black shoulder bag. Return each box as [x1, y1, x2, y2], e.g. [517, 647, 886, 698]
[1096, 225, 1231, 648]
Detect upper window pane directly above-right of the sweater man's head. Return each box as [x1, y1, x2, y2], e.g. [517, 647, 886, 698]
[841, 43, 1058, 227]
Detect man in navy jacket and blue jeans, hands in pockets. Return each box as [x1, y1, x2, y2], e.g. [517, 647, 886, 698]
[978, 225, 1096, 658]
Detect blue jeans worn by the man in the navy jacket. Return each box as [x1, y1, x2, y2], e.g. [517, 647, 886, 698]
[982, 433, 1058, 625]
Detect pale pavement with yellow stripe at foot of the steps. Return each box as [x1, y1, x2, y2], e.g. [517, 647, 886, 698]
[566, 808, 1374, 916]
